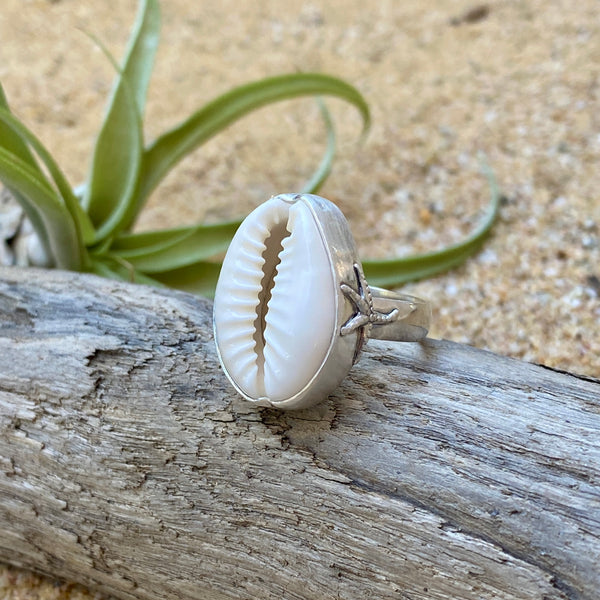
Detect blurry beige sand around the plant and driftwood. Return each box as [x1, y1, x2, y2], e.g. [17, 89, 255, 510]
[0, 0, 600, 600]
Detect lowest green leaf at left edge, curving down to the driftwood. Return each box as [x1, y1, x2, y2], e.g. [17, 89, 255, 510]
[0, 148, 82, 271]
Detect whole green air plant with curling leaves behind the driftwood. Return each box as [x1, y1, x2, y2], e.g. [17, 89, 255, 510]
[0, 0, 498, 296]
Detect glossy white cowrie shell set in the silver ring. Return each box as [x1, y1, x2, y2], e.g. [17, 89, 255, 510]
[214, 195, 354, 408]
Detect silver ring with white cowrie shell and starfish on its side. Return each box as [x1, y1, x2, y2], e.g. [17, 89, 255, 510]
[213, 194, 431, 409]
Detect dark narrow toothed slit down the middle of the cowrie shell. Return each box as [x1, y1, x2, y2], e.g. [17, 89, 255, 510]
[254, 219, 291, 381]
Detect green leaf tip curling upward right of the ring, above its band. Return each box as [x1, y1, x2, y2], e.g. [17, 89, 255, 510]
[363, 162, 500, 287]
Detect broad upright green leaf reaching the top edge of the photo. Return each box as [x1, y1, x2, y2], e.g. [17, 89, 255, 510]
[86, 0, 160, 240]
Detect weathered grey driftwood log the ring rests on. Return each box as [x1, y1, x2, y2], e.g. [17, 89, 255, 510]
[0, 269, 600, 600]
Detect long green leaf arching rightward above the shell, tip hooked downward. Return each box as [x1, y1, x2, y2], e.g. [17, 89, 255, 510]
[137, 73, 370, 206]
